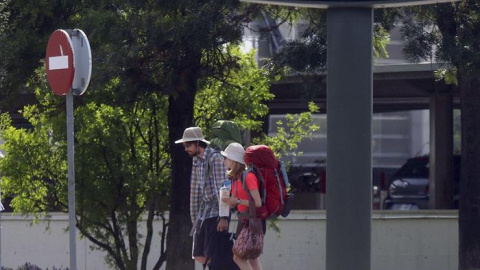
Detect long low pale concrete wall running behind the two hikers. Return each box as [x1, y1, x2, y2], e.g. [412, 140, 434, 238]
[0, 210, 458, 270]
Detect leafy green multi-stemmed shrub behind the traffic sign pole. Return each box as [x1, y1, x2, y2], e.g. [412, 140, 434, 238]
[0, 74, 170, 269]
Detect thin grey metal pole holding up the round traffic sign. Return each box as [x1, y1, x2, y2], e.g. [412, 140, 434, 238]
[66, 91, 77, 270]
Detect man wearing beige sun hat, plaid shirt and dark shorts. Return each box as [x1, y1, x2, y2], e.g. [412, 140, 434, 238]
[175, 127, 238, 270]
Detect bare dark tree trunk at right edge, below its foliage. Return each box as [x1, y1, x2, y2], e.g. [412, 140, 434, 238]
[458, 74, 480, 270]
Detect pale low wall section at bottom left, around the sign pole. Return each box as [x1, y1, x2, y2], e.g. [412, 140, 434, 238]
[1, 213, 107, 270]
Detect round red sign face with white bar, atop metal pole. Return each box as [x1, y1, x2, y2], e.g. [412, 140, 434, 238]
[45, 29, 75, 96]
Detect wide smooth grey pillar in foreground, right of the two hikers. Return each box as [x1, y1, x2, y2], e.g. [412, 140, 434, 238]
[326, 8, 373, 270]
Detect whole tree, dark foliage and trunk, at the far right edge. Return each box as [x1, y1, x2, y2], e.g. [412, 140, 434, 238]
[404, 0, 480, 270]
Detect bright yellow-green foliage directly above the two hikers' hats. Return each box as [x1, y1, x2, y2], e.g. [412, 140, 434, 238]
[195, 46, 273, 134]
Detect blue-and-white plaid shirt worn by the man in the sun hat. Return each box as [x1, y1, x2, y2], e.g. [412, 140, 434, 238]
[190, 147, 226, 224]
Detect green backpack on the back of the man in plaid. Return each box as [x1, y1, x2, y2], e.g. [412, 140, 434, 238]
[210, 120, 244, 151]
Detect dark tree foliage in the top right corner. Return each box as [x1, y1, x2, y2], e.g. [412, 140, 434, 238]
[402, 0, 480, 78]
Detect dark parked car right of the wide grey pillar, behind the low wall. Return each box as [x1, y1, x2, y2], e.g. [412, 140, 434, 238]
[383, 155, 460, 210]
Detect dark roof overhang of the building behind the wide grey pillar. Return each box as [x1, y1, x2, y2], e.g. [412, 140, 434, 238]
[268, 63, 459, 114]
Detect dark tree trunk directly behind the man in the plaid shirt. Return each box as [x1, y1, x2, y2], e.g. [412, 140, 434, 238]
[166, 68, 197, 270]
